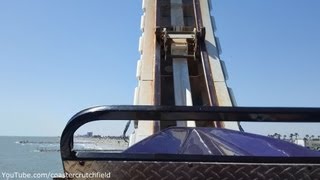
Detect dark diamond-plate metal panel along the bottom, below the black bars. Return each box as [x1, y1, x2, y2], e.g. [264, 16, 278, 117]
[64, 161, 320, 180]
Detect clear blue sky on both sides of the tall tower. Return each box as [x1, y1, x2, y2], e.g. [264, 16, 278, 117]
[0, 0, 320, 136]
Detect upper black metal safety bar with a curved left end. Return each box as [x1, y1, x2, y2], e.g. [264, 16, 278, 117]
[60, 106, 320, 159]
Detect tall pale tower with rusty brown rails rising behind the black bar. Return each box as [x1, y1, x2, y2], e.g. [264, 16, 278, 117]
[130, 0, 239, 144]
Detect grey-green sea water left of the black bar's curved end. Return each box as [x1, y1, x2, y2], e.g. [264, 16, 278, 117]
[0, 136, 63, 175]
